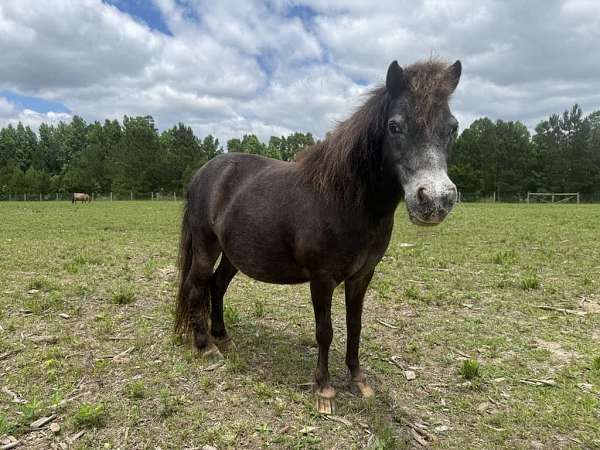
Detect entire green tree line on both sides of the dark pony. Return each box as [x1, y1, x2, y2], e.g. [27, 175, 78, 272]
[0, 105, 600, 195]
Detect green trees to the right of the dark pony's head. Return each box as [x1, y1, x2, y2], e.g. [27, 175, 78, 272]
[448, 104, 600, 194]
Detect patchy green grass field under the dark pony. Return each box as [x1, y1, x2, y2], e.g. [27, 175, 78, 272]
[0, 202, 600, 449]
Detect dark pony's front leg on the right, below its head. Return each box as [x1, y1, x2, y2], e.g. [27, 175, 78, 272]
[344, 271, 374, 397]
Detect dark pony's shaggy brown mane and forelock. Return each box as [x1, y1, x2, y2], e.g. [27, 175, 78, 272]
[296, 59, 454, 202]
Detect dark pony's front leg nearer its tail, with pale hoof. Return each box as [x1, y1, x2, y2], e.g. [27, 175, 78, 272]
[310, 276, 336, 414]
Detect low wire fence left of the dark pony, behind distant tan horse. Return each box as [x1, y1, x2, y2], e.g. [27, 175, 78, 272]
[0, 191, 183, 202]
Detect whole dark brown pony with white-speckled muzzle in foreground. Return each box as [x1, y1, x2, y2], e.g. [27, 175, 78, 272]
[175, 60, 461, 413]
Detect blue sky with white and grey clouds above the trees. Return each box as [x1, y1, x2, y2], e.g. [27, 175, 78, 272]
[0, 0, 600, 142]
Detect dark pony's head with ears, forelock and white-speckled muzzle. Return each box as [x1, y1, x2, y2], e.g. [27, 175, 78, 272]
[382, 60, 461, 225]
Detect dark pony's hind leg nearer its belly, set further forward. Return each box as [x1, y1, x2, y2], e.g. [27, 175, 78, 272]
[210, 253, 238, 347]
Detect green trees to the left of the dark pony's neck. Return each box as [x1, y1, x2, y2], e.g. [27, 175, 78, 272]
[0, 116, 314, 195]
